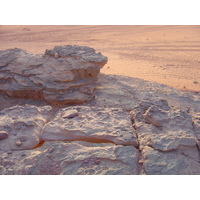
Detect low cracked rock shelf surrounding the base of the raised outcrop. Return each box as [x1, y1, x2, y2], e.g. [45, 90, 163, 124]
[0, 45, 200, 175]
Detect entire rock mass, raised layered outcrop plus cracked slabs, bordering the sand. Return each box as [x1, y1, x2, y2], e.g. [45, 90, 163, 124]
[0, 46, 200, 175]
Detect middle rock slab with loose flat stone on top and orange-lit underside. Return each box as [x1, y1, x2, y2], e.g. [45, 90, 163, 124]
[40, 106, 138, 147]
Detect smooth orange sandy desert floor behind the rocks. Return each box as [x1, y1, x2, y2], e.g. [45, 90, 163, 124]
[0, 25, 200, 92]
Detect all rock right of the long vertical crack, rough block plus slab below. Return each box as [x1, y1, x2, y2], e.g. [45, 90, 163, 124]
[131, 99, 200, 174]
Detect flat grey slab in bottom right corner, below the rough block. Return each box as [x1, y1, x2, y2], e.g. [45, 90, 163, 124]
[143, 147, 200, 175]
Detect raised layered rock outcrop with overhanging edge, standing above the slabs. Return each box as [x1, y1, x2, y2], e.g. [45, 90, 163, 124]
[0, 45, 107, 104]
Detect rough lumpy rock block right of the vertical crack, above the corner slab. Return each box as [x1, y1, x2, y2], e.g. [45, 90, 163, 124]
[131, 100, 197, 151]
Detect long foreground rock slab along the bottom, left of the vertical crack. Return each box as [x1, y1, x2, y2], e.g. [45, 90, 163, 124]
[0, 142, 138, 175]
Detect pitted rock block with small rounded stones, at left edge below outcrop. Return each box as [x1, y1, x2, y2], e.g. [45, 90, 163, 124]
[0, 105, 52, 152]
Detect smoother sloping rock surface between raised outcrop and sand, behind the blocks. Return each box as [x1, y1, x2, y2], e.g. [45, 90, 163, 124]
[91, 73, 200, 112]
